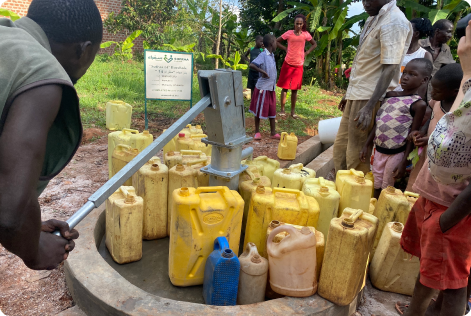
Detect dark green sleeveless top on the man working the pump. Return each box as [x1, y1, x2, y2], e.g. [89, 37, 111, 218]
[0, 17, 82, 196]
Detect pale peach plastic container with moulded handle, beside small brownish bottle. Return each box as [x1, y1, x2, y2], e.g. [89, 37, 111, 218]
[267, 225, 317, 297]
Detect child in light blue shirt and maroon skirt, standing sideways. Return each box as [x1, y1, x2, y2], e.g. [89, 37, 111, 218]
[249, 34, 280, 140]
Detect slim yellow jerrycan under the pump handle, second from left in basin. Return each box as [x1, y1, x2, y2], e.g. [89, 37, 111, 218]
[132, 157, 168, 240]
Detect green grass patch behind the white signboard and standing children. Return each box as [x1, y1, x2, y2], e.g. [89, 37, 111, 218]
[76, 60, 341, 136]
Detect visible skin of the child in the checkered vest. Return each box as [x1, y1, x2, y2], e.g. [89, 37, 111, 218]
[360, 62, 429, 198]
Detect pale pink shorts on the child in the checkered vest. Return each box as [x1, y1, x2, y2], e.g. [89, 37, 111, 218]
[372, 150, 404, 189]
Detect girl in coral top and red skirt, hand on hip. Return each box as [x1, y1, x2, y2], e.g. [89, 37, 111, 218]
[276, 14, 317, 119]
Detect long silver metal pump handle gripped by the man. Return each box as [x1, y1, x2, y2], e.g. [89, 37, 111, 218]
[54, 94, 211, 236]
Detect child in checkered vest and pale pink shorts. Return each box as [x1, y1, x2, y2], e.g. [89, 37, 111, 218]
[360, 58, 433, 198]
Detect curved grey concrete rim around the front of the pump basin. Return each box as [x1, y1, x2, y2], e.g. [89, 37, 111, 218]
[65, 206, 359, 316]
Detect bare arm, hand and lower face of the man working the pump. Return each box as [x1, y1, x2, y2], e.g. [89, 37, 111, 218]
[0, 41, 99, 270]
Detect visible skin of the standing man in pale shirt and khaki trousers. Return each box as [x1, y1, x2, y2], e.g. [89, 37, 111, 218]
[338, 0, 399, 131]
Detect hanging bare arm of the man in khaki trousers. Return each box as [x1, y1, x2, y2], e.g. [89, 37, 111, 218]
[355, 64, 399, 131]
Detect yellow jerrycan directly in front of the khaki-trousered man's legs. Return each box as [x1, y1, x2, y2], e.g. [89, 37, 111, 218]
[335, 169, 373, 216]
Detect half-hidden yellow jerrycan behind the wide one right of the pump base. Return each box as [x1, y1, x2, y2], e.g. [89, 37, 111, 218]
[272, 163, 316, 190]
